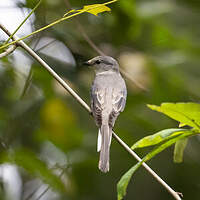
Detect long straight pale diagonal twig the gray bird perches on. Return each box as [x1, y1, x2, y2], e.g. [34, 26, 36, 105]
[0, 24, 181, 200]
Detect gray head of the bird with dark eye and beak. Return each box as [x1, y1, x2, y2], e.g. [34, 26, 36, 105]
[84, 56, 119, 73]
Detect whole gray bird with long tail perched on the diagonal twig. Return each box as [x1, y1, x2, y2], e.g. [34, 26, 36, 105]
[85, 56, 127, 173]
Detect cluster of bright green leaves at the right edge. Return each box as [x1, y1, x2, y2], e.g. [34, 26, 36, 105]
[117, 103, 200, 200]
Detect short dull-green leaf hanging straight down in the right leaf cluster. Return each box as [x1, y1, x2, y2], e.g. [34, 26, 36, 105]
[174, 138, 188, 163]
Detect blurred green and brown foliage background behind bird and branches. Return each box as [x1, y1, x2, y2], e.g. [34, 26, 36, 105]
[0, 0, 200, 200]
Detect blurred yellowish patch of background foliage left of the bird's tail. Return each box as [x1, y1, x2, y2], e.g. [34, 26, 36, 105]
[36, 99, 83, 151]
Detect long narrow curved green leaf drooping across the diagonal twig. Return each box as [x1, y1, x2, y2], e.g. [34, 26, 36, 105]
[117, 130, 197, 200]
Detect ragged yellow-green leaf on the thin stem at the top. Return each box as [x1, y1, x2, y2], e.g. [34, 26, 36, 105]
[64, 4, 111, 17]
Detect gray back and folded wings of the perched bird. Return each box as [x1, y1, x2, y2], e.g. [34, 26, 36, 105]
[92, 73, 126, 125]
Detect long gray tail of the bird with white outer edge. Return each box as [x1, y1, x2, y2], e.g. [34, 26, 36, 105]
[98, 124, 112, 173]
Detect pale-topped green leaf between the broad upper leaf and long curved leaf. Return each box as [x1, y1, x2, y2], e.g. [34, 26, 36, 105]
[131, 128, 187, 149]
